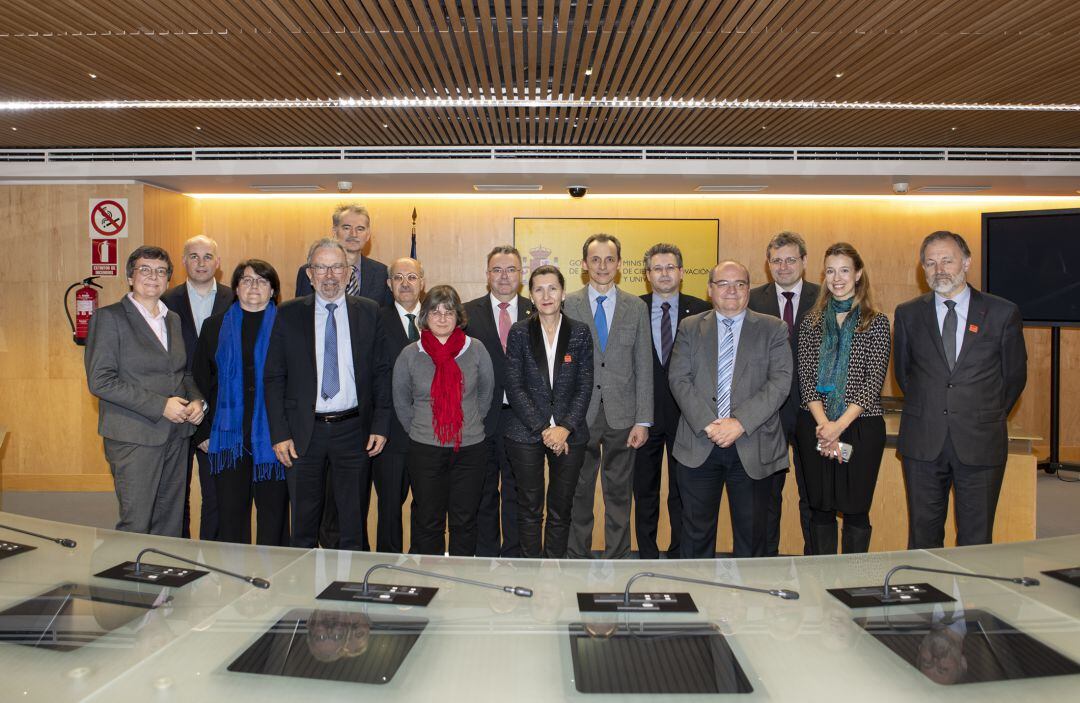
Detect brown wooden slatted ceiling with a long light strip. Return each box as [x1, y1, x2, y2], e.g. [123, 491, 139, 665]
[0, 0, 1080, 147]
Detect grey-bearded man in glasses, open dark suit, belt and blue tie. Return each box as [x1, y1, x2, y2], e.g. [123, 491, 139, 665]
[264, 239, 391, 550]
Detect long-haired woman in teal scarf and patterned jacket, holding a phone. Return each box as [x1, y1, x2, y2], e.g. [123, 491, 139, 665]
[795, 242, 891, 554]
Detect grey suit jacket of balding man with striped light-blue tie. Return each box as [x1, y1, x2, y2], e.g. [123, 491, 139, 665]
[667, 310, 793, 478]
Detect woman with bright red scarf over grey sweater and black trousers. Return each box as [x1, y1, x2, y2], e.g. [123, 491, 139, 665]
[393, 285, 494, 556]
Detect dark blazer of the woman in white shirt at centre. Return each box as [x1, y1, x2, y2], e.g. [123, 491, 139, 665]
[503, 315, 593, 444]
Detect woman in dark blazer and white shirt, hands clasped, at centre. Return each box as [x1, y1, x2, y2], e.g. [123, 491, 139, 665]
[503, 266, 593, 559]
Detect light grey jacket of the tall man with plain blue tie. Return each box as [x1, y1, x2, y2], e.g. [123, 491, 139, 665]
[563, 286, 652, 430]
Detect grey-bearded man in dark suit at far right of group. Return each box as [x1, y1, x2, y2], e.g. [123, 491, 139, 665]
[893, 231, 1027, 549]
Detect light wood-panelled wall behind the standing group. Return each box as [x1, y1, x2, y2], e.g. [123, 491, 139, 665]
[0, 186, 1080, 490]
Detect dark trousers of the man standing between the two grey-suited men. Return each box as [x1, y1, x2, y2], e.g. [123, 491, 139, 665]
[634, 425, 683, 559]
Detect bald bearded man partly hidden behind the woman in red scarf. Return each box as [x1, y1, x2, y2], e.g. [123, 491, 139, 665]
[372, 258, 423, 553]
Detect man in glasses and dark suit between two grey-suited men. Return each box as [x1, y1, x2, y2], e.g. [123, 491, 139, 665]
[634, 244, 710, 559]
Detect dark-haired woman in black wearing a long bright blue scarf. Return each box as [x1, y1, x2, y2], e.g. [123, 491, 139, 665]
[192, 259, 289, 546]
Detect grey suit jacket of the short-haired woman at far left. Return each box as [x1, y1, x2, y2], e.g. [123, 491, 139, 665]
[84, 295, 202, 446]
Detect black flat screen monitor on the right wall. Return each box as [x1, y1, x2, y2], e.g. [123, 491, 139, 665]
[983, 209, 1080, 327]
